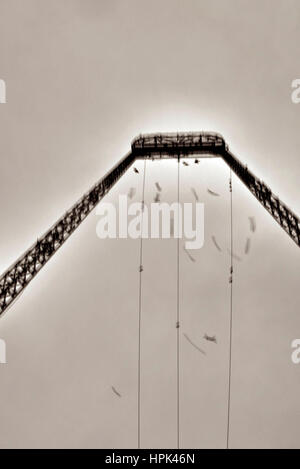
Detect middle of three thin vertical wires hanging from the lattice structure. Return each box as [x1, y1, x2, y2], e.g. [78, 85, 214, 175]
[176, 155, 180, 449]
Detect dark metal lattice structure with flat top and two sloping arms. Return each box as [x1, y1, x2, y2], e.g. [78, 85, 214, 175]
[0, 132, 300, 316]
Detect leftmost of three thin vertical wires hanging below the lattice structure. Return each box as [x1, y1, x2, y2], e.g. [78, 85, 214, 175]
[137, 160, 146, 449]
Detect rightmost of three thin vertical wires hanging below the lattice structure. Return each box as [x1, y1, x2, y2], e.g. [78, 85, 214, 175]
[226, 169, 233, 449]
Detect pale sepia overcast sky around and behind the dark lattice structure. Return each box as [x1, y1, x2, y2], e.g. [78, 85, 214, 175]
[0, 0, 300, 448]
